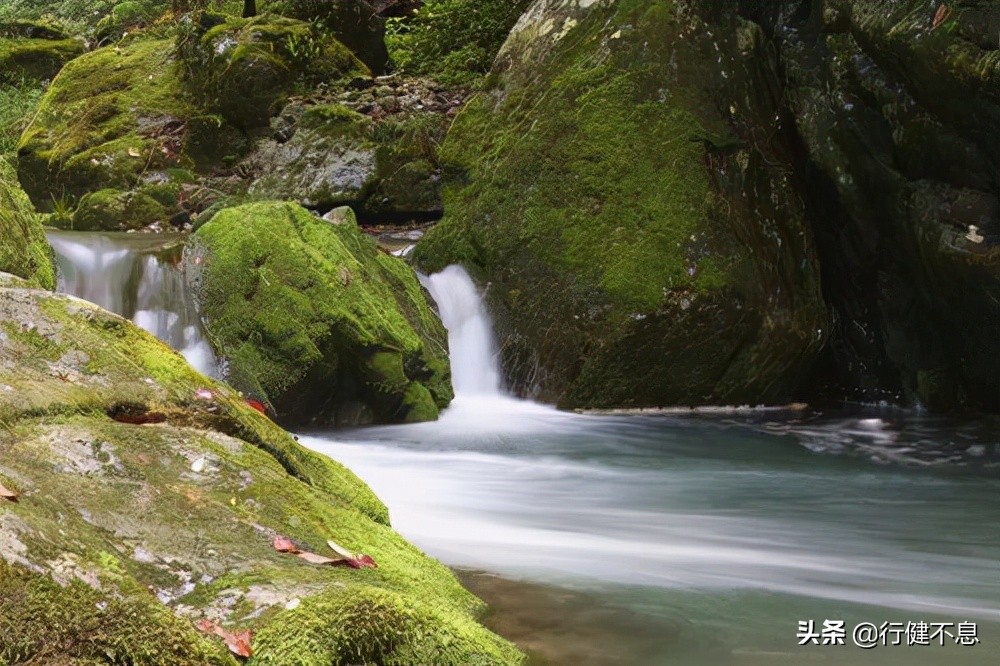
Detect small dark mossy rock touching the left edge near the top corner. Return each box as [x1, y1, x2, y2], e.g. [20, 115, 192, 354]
[0, 21, 84, 85]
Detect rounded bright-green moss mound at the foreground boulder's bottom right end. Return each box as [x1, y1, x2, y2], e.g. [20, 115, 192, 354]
[256, 588, 520, 666]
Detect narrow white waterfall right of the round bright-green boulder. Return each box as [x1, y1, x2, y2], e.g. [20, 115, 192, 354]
[423, 265, 502, 397]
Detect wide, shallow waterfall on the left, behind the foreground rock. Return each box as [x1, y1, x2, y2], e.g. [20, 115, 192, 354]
[48, 231, 217, 375]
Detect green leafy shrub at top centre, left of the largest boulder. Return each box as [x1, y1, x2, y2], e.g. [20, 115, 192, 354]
[386, 0, 530, 85]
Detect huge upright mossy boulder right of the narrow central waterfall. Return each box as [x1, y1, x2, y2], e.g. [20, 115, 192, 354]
[415, 0, 827, 407]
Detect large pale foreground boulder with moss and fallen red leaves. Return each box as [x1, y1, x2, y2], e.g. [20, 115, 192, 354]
[0, 272, 521, 666]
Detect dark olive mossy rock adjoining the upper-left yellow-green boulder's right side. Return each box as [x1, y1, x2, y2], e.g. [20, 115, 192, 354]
[178, 15, 370, 130]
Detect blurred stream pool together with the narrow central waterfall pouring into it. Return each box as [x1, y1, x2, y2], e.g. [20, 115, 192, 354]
[302, 267, 1000, 666]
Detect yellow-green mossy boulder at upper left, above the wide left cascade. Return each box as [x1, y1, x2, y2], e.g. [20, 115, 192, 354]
[17, 39, 200, 211]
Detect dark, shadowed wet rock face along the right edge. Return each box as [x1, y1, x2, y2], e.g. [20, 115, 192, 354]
[765, 0, 1000, 410]
